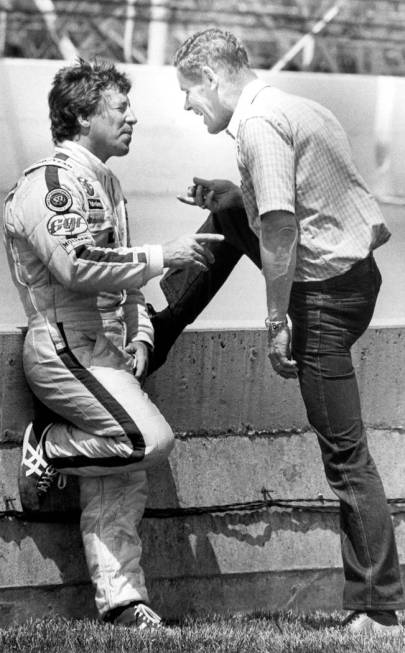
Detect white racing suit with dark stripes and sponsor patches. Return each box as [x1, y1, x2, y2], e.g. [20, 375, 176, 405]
[5, 141, 173, 616]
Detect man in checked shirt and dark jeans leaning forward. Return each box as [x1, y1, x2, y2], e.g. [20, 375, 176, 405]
[150, 29, 405, 634]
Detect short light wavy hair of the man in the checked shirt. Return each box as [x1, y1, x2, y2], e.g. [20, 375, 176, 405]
[174, 27, 249, 80]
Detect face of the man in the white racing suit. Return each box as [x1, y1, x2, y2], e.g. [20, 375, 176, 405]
[88, 88, 137, 162]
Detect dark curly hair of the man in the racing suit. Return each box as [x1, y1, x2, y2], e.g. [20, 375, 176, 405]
[48, 59, 131, 143]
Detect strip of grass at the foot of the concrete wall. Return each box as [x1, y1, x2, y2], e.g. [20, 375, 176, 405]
[0, 612, 405, 653]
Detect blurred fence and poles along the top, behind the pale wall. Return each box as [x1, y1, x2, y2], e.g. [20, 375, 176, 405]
[0, 0, 405, 75]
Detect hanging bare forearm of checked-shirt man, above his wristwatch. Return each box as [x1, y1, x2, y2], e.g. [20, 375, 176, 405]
[260, 211, 298, 322]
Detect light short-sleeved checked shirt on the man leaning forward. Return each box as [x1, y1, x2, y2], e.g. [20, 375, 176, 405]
[227, 79, 390, 281]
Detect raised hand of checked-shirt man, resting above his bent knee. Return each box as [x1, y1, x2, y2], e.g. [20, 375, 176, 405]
[193, 177, 243, 213]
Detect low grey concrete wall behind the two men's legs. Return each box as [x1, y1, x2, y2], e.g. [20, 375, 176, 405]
[0, 328, 405, 626]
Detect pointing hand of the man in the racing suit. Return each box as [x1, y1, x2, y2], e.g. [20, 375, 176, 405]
[162, 234, 224, 271]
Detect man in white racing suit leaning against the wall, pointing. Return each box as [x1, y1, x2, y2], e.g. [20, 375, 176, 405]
[4, 60, 223, 629]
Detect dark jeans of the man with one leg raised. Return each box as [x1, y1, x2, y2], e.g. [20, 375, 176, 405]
[156, 210, 405, 611]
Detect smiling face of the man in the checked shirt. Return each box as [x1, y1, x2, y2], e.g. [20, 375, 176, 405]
[177, 70, 232, 134]
